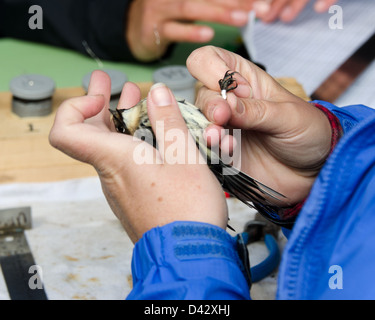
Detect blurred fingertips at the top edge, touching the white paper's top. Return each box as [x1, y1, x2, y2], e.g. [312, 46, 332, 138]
[253, 0, 338, 22]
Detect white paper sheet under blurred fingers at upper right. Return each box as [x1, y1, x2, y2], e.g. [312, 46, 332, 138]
[243, 0, 375, 106]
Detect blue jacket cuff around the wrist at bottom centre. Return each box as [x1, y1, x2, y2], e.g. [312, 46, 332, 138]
[127, 222, 250, 300]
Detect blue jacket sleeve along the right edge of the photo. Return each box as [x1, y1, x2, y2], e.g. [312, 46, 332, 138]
[276, 102, 375, 300]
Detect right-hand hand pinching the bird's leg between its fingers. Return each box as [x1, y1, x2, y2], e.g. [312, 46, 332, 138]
[187, 46, 331, 204]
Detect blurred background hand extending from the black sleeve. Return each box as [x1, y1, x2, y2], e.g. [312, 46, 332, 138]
[125, 0, 251, 61]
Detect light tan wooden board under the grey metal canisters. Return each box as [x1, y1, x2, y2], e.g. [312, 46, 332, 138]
[0, 78, 308, 183]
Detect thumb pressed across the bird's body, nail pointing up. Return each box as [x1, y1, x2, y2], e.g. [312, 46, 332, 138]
[147, 83, 203, 164]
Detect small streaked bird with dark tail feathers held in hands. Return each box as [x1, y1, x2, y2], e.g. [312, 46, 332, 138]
[110, 71, 294, 228]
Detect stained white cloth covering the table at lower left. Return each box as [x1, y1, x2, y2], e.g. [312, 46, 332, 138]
[0, 177, 283, 300]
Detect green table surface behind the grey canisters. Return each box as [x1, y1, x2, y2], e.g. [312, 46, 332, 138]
[0, 24, 241, 92]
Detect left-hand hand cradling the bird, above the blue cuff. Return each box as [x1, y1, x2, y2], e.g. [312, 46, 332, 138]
[49, 71, 228, 242]
